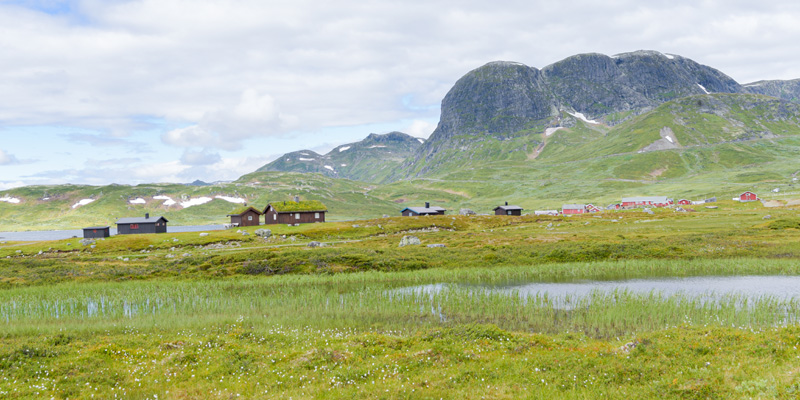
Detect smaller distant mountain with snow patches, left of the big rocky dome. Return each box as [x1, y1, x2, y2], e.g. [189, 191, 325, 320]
[258, 132, 425, 182]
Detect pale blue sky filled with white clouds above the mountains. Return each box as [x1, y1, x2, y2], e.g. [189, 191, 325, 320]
[0, 0, 800, 190]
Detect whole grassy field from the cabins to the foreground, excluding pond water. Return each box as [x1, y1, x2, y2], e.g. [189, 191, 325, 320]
[0, 201, 800, 399]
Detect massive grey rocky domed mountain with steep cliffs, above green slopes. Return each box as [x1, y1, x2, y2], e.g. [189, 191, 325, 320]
[388, 51, 798, 181]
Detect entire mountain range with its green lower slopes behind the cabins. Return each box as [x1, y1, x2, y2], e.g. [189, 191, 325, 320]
[0, 51, 800, 231]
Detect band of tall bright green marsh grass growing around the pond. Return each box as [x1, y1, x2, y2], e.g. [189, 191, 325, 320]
[6, 259, 800, 337]
